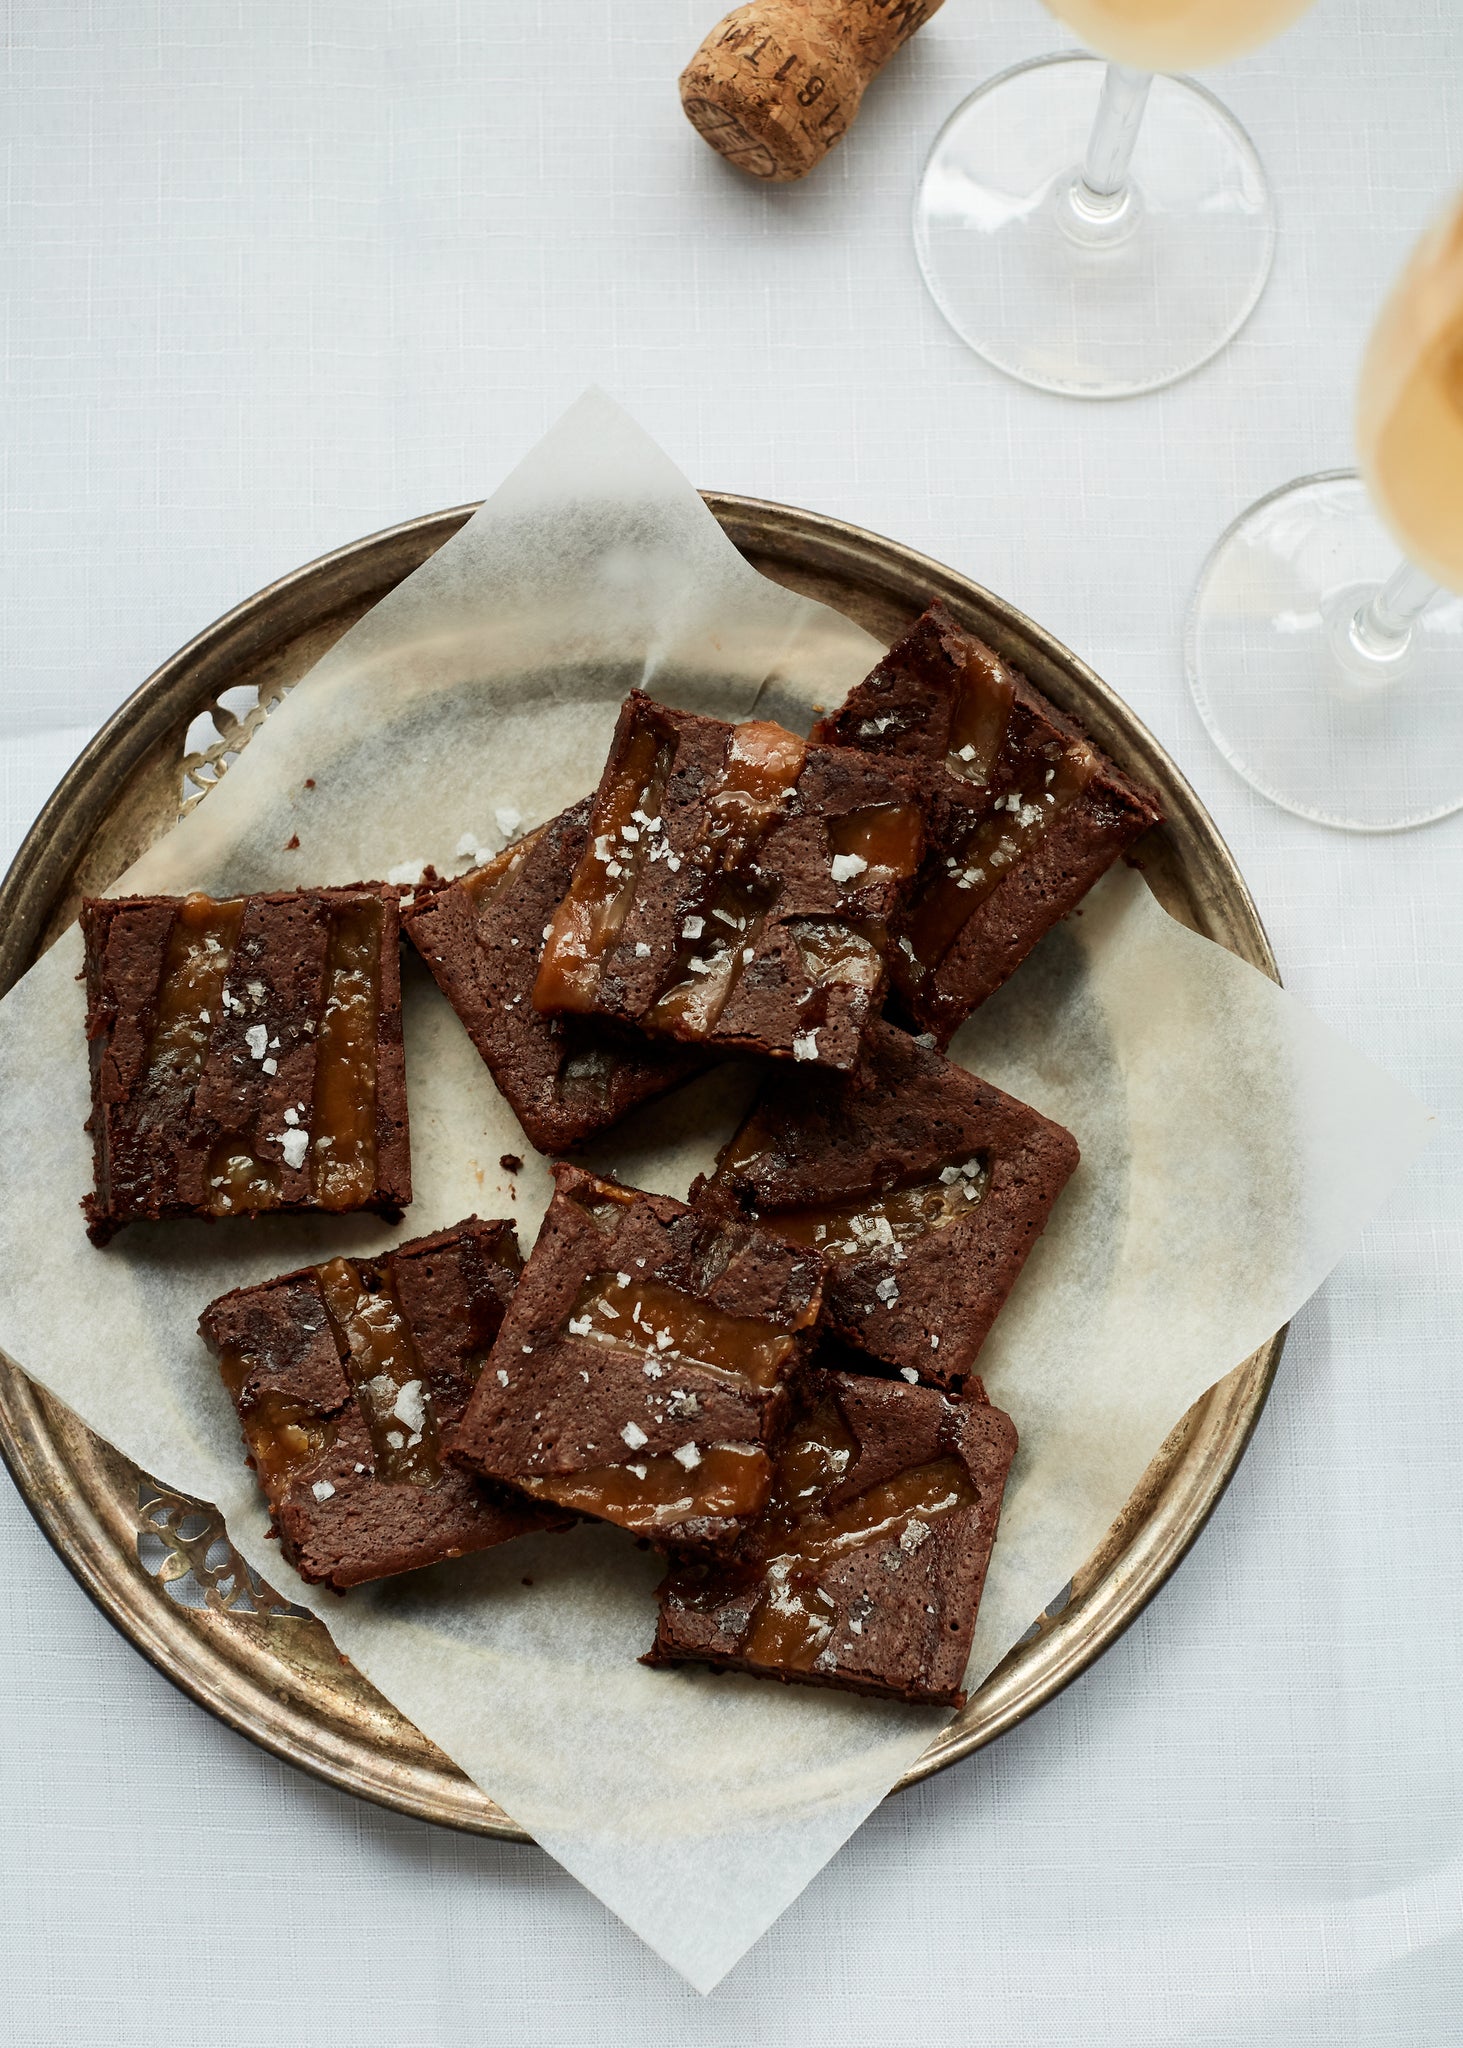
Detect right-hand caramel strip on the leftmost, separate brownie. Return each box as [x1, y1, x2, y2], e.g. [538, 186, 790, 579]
[309, 897, 383, 1208]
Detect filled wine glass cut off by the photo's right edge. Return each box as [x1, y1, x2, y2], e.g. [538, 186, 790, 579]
[1186, 199, 1463, 831]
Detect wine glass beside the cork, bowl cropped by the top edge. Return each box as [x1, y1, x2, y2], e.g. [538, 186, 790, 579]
[914, 0, 1311, 397]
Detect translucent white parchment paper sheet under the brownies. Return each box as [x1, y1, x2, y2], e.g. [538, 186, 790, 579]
[0, 393, 1426, 1991]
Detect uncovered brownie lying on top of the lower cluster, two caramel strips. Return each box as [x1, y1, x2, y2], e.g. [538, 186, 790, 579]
[449, 1165, 822, 1550]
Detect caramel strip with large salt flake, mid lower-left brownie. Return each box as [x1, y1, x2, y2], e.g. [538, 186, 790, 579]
[316, 1260, 443, 1487]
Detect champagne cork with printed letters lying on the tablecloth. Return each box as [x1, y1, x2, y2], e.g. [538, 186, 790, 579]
[680, 0, 941, 184]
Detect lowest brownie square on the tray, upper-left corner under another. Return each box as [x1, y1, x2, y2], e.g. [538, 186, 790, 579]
[641, 1368, 1016, 1706]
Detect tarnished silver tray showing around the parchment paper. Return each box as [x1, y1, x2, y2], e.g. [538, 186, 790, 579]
[0, 492, 1285, 1841]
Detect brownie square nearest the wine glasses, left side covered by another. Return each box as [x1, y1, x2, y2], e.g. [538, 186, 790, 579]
[813, 604, 1162, 1047]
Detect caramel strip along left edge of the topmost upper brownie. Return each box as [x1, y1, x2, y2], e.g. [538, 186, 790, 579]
[533, 721, 676, 1010]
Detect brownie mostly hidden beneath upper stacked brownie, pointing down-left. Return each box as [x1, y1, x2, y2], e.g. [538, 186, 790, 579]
[402, 797, 703, 1153]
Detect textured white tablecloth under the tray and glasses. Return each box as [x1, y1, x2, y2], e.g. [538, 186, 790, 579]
[0, 0, 1463, 2048]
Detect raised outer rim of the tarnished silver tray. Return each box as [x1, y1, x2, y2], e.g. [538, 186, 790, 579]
[0, 492, 1287, 1843]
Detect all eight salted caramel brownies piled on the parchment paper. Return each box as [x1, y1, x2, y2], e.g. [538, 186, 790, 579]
[82, 606, 1158, 1704]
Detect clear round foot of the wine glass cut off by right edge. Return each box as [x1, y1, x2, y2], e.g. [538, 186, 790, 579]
[1184, 469, 1463, 831]
